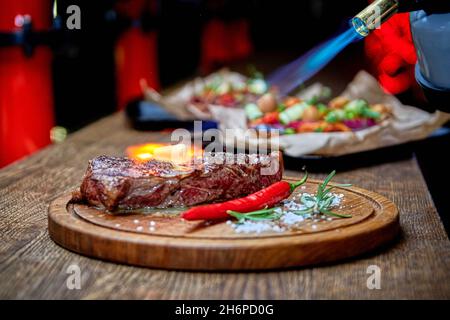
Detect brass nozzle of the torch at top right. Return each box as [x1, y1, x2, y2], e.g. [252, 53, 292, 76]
[352, 0, 399, 37]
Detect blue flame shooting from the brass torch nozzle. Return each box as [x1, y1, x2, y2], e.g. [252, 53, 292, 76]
[268, 26, 363, 96]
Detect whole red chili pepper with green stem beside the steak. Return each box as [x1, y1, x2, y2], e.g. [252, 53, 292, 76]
[181, 174, 308, 220]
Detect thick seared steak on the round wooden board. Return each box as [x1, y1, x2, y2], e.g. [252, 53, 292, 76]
[74, 152, 283, 211]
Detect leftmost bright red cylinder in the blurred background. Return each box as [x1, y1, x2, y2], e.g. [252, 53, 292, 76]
[0, 0, 54, 167]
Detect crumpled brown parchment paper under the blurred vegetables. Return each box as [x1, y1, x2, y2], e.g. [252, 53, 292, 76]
[146, 70, 450, 157]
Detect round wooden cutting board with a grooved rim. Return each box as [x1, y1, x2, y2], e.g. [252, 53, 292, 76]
[48, 178, 400, 270]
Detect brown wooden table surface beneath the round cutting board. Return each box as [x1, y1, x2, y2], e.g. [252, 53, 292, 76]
[0, 114, 450, 299]
